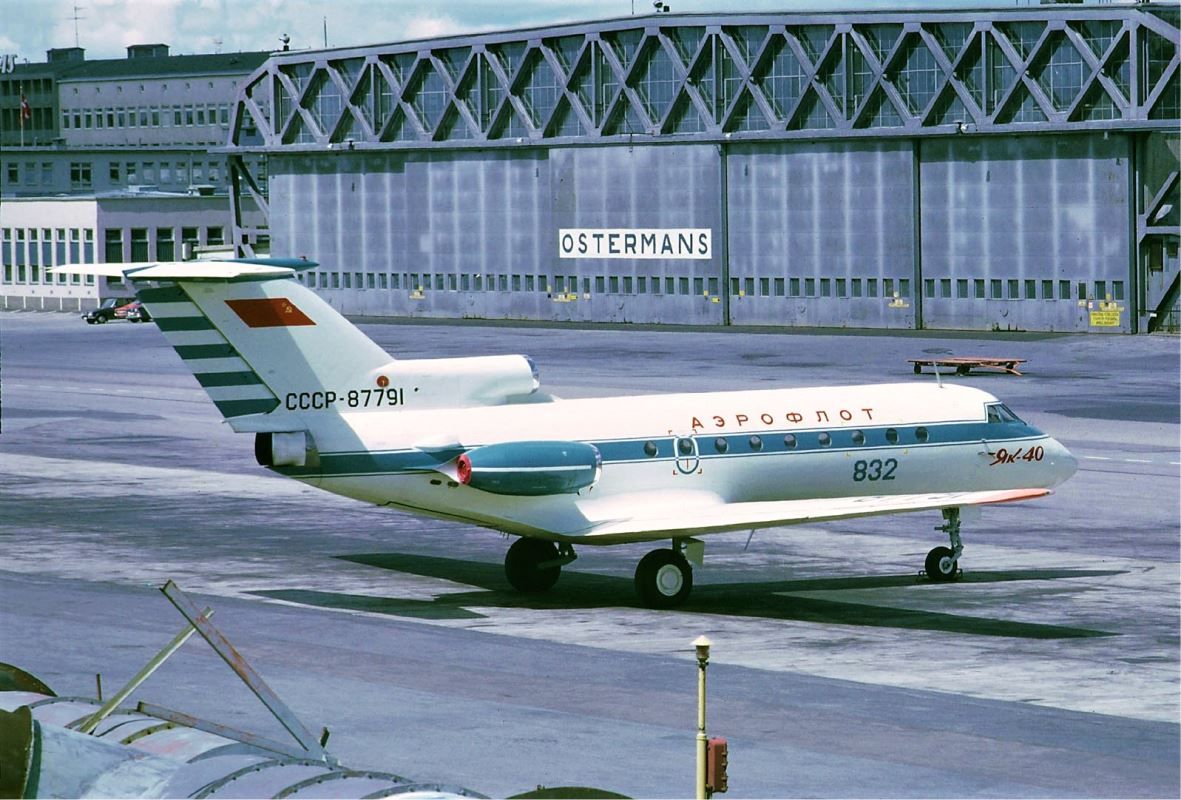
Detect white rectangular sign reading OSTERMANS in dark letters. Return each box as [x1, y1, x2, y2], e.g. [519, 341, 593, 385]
[557, 228, 713, 259]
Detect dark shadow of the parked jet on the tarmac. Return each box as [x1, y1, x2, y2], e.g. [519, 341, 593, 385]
[246, 553, 1121, 639]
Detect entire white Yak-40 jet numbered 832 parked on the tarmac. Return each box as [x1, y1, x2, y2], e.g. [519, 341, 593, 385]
[57, 259, 1077, 607]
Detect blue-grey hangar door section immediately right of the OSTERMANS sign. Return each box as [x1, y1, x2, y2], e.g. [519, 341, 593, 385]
[726, 142, 915, 329]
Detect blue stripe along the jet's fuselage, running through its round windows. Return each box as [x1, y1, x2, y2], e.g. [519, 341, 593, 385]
[276, 422, 1045, 477]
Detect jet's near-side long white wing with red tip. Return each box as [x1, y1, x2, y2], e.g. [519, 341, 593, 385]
[583, 488, 1050, 544]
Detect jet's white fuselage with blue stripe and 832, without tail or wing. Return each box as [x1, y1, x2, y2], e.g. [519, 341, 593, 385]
[276, 383, 1075, 544]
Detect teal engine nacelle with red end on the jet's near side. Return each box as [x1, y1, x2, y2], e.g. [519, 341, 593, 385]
[456, 442, 602, 496]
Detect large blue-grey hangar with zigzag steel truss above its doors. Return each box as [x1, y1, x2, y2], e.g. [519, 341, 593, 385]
[227, 4, 1181, 332]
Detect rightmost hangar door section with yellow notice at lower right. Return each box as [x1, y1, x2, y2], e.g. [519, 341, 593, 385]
[921, 134, 1131, 332]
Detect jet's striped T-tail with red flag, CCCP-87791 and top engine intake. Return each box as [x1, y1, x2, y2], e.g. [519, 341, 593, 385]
[54, 259, 540, 432]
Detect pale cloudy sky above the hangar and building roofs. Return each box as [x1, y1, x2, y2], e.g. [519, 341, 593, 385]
[0, 0, 1036, 63]
